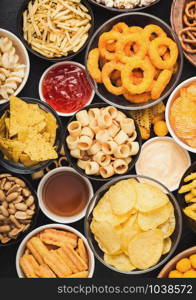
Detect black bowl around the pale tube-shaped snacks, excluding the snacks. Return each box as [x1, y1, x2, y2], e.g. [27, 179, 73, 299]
[64, 103, 142, 181]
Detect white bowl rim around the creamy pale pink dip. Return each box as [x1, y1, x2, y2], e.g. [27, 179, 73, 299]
[135, 136, 191, 192]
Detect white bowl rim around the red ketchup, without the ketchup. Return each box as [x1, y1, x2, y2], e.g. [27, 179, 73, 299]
[39, 61, 95, 117]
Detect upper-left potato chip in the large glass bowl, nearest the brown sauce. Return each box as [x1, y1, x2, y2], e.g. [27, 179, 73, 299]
[108, 180, 136, 215]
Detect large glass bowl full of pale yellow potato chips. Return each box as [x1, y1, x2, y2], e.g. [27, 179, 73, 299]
[85, 175, 182, 275]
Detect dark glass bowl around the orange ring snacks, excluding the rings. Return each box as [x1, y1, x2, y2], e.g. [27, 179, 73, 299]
[85, 13, 183, 110]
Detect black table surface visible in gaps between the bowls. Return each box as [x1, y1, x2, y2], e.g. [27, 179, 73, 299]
[0, 0, 196, 280]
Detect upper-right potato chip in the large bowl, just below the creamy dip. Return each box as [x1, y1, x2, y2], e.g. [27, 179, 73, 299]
[135, 183, 169, 213]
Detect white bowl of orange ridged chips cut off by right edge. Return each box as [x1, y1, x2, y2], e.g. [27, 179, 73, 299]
[165, 77, 196, 153]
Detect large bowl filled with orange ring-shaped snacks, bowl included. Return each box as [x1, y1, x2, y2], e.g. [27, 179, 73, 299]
[85, 12, 183, 110]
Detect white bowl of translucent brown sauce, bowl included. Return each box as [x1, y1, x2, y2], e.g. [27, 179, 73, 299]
[37, 167, 93, 224]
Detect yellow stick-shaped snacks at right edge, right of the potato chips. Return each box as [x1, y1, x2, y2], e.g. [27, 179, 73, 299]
[178, 172, 196, 221]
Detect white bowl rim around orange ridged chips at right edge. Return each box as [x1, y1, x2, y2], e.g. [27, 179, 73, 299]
[165, 77, 196, 153]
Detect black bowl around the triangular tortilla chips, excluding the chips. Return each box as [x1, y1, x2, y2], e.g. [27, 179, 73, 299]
[0, 97, 64, 174]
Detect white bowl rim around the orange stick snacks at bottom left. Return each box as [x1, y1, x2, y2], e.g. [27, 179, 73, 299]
[16, 224, 95, 278]
